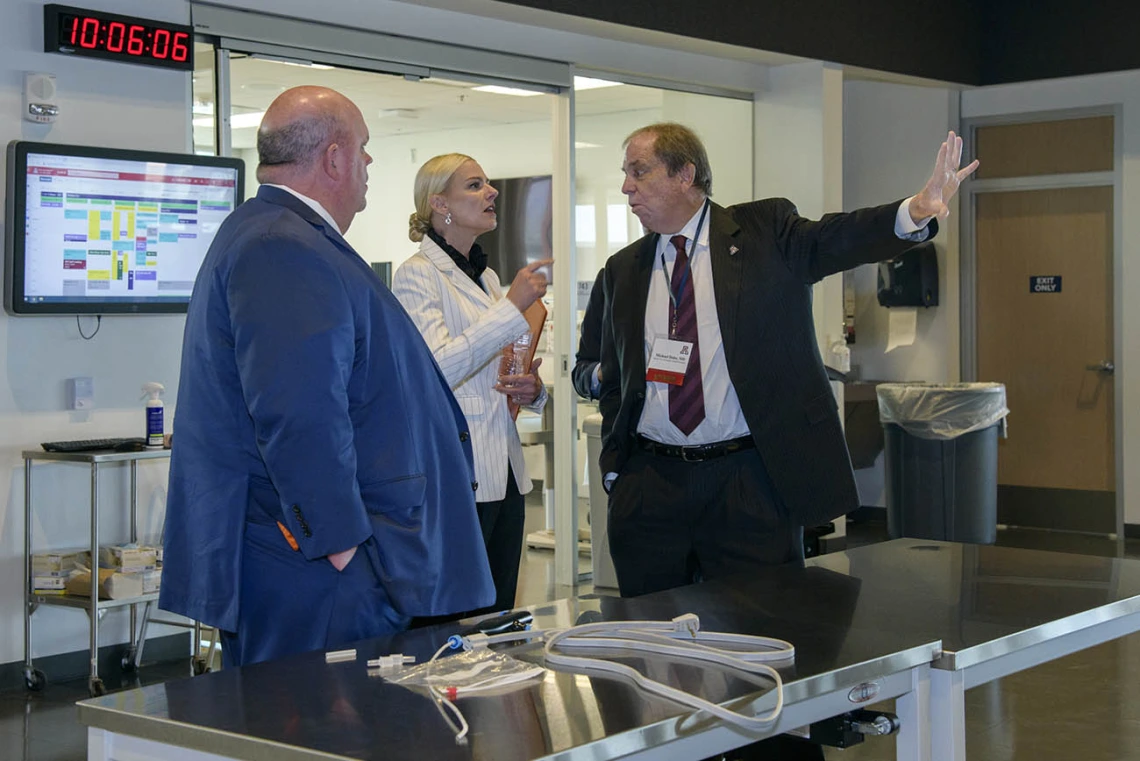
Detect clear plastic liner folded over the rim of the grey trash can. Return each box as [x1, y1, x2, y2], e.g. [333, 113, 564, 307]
[876, 383, 1009, 439]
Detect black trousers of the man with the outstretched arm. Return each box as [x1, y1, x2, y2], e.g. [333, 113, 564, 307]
[608, 449, 804, 597]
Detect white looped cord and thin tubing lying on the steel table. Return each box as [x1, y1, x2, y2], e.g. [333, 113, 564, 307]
[419, 613, 796, 744]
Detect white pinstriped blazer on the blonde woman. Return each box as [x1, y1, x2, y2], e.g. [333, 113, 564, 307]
[392, 237, 546, 502]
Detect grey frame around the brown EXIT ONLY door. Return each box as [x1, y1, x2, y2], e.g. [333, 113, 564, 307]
[959, 104, 1125, 539]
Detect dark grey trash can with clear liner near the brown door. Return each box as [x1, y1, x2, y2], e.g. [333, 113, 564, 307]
[877, 383, 1009, 545]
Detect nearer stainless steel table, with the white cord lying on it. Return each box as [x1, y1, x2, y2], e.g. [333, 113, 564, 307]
[79, 567, 939, 761]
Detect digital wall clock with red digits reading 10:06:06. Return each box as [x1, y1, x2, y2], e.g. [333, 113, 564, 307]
[43, 5, 194, 71]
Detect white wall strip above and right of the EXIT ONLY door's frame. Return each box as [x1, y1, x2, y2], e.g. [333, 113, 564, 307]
[962, 72, 1140, 523]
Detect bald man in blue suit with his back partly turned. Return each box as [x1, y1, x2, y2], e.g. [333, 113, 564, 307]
[160, 87, 495, 665]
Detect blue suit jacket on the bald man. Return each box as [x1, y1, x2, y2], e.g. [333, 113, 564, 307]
[160, 187, 494, 631]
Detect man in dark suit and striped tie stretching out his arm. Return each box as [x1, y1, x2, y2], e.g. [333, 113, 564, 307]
[600, 124, 977, 596]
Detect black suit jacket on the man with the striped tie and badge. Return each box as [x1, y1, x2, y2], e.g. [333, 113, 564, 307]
[600, 198, 937, 525]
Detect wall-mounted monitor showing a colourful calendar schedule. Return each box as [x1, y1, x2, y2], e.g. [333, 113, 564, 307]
[3, 140, 245, 316]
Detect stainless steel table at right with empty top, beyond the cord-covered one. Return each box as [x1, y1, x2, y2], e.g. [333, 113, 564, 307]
[811, 539, 1140, 761]
